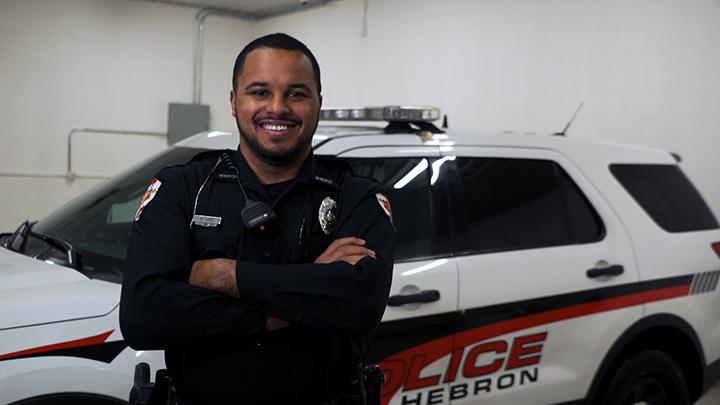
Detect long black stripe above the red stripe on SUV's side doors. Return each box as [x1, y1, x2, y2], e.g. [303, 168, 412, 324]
[368, 275, 694, 362]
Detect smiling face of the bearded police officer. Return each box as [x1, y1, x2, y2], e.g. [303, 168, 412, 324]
[230, 48, 322, 173]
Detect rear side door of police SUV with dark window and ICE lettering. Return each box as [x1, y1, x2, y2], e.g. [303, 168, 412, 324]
[444, 147, 642, 404]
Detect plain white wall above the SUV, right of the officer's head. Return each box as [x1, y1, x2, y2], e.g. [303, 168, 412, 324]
[256, 0, 720, 216]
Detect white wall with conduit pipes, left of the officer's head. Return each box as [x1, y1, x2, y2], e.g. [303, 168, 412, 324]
[0, 0, 252, 231]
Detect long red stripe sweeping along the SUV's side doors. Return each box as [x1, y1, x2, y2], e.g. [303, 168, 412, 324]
[380, 283, 690, 404]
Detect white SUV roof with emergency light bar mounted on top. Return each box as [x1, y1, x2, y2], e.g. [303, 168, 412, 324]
[177, 106, 675, 167]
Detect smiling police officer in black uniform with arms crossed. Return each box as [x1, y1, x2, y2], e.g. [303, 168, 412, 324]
[120, 34, 393, 405]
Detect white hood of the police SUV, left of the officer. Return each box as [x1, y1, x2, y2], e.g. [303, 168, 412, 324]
[0, 248, 120, 330]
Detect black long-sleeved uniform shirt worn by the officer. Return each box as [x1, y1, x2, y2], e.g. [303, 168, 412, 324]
[120, 152, 393, 404]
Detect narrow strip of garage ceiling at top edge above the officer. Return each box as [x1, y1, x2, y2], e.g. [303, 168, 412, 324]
[133, 0, 335, 20]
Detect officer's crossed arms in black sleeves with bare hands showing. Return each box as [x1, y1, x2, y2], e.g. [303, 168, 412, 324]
[120, 171, 393, 350]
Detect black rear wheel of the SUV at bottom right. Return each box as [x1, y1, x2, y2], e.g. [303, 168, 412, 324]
[600, 350, 690, 405]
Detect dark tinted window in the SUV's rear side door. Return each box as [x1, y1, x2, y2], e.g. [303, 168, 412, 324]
[455, 157, 604, 252]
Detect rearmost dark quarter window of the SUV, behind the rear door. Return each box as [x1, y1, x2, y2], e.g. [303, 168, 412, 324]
[610, 164, 718, 232]
